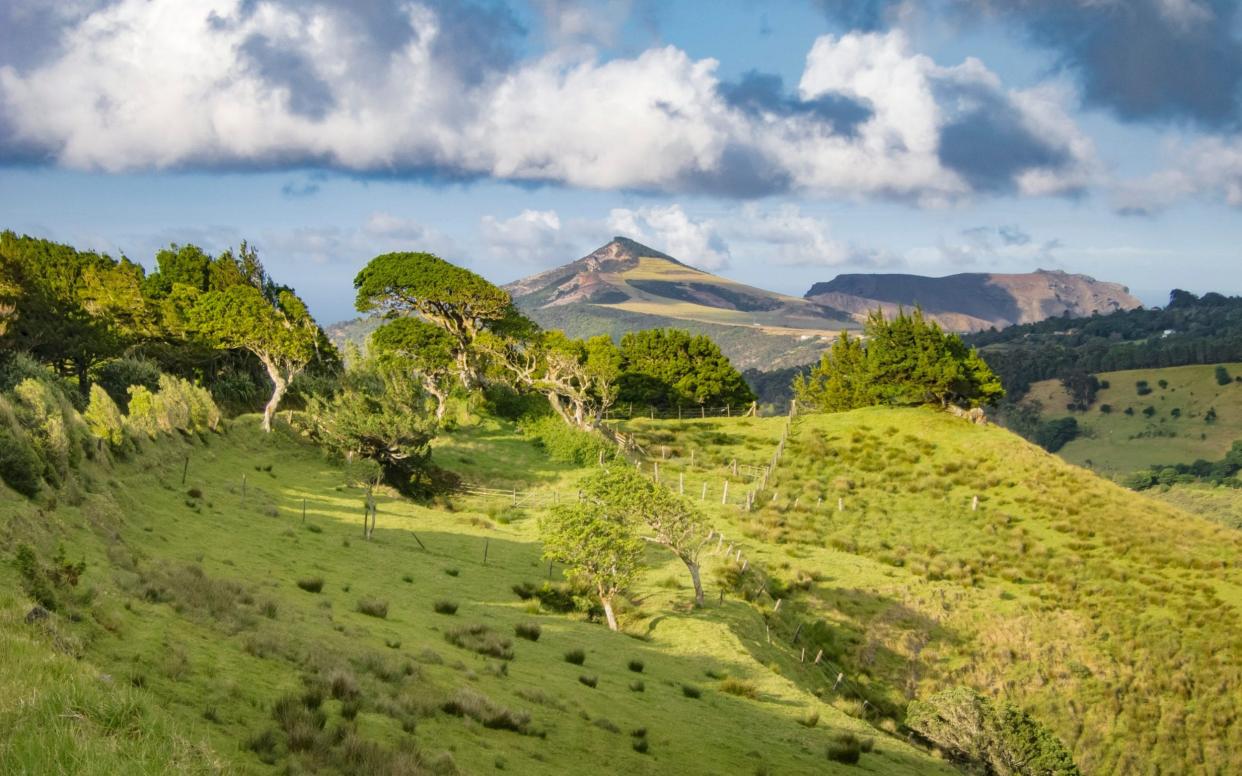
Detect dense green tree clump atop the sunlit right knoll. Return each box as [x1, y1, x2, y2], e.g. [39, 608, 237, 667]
[794, 309, 1005, 412]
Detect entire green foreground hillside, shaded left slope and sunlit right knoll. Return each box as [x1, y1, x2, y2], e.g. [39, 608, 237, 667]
[0, 410, 1242, 774]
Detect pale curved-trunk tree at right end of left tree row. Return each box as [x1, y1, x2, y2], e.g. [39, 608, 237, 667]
[191, 284, 322, 432]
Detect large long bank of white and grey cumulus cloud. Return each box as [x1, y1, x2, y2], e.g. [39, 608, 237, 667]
[0, 0, 1092, 202]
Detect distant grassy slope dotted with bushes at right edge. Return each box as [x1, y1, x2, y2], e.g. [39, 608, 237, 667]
[1028, 364, 1242, 474]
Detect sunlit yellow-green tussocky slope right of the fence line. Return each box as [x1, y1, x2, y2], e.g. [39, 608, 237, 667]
[618, 410, 1242, 774]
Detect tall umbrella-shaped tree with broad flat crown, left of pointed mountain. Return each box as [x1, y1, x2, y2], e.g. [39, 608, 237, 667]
[354, 253, 513, 389]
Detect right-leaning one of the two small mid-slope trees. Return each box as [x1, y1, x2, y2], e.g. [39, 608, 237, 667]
[581, 466, 715, 606]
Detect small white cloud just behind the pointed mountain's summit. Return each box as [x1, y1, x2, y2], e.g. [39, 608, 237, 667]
[607, 205, 729, 269]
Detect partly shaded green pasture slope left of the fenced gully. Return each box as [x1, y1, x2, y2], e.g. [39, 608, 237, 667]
[0, 418, 944, 774]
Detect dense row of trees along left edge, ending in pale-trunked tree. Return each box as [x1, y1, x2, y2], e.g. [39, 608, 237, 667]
[0, 231, 339, 430]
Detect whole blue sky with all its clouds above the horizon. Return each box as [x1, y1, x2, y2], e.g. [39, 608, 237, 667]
[0, 0, 1242, 322]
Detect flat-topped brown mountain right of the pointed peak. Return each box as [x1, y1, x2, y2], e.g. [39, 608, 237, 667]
[806, 269, 1141, 332]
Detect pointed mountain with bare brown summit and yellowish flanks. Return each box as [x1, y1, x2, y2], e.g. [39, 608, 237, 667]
[504, 237, 856, 368]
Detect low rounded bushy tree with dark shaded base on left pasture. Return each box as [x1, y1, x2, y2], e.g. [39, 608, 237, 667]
[306, 361, 435, 493]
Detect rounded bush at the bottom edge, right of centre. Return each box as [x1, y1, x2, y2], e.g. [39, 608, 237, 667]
[905, 687, 1079, 776]
